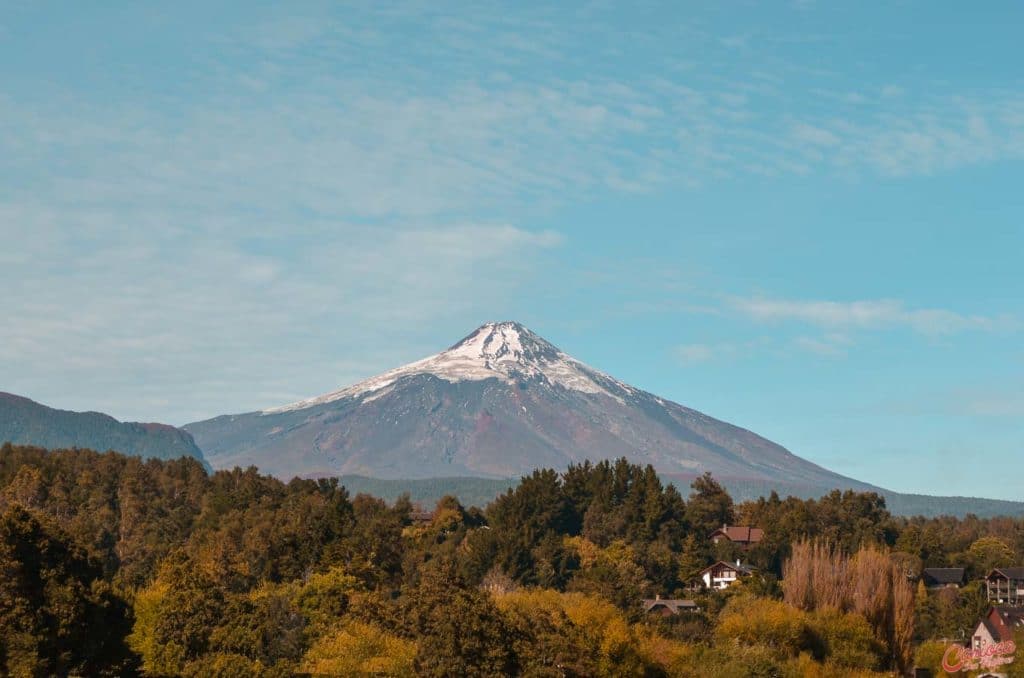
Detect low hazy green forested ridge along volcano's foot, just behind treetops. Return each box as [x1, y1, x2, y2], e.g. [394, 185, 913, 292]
[339, 474, 1024, 518]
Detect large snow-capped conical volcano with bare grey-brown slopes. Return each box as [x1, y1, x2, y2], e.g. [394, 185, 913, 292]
[184, 323, 871, 493]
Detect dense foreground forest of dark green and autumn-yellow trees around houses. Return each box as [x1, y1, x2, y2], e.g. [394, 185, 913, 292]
[0, 446, 1024, 676]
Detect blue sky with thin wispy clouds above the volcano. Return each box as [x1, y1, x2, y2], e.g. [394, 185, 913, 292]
[0, 2, 1024, 500]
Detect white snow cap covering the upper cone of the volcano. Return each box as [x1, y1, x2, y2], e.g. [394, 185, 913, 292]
[262, 321, 635, 414]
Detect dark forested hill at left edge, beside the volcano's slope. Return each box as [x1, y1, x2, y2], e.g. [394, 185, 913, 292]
[0, 392, 210, 469]
